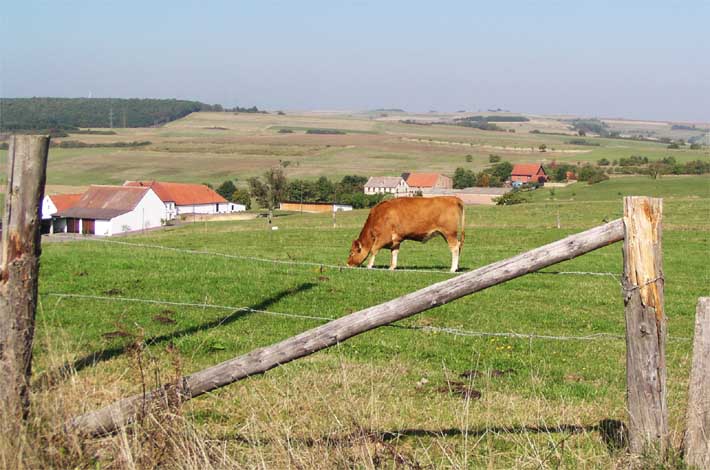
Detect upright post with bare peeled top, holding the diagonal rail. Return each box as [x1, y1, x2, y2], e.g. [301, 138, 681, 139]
[623, 197, 668, 456]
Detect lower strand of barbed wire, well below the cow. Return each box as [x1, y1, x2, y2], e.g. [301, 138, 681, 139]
[42, 292, 692, 341]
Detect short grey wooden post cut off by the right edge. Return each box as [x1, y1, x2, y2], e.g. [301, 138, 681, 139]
[683, 297, 710, 468]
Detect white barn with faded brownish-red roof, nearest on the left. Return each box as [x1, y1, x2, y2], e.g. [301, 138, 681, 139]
[52, 185, 165, 236]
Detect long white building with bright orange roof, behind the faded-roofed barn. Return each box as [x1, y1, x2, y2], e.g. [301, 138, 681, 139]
[123, 181, 246, 220]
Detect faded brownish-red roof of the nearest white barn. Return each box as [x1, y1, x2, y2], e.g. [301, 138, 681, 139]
[56, 185, 149, 220]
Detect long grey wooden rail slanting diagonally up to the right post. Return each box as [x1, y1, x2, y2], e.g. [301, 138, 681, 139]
[70, 219, 625, 436]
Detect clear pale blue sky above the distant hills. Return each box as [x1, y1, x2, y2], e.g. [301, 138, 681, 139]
[0, 0, 710, 121]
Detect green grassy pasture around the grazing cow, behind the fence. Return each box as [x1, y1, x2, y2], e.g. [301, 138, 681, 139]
[19, 175, 710, 468]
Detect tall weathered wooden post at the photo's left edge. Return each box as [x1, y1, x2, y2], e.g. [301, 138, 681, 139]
[0, 135, 49, 419]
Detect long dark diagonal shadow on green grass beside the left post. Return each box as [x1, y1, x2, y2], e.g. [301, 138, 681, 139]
[37, 282, 317, 388]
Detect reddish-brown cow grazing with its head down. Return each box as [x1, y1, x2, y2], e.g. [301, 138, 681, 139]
[348, 196, 464, 273]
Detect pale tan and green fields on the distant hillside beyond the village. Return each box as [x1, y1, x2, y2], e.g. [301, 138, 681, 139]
[0, 112, 710, 192]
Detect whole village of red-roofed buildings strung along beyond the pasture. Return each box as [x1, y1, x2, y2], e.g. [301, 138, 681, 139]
[42, 164, 548, 236]
